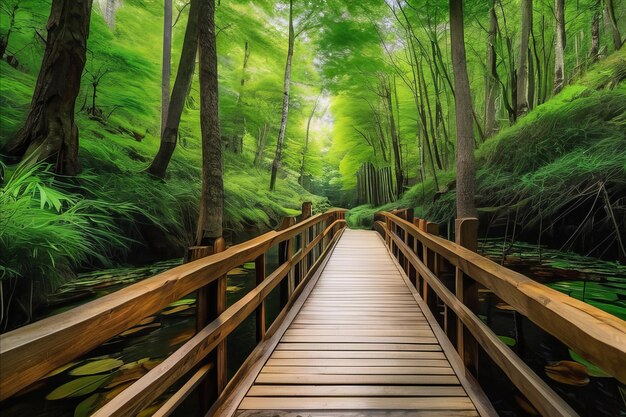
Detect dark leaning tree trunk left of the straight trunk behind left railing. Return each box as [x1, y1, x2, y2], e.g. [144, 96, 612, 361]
[147, 0, 200, 178]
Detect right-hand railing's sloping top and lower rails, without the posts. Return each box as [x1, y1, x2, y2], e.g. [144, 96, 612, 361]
[377, 212, 626, 416]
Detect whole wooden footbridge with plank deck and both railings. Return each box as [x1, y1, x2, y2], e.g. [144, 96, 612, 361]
[0, 205, 626, 417]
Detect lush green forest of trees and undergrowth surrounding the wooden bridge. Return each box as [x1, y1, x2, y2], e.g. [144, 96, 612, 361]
[0, 0, 626, 416]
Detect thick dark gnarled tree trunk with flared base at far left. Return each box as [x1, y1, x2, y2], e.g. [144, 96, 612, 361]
[4, 0, 92, 175]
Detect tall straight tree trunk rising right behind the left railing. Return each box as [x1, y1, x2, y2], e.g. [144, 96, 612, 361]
[196, 0, 224, 245]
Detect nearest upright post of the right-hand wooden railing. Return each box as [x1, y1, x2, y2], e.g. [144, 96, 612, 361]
[455, 217, 478, 374]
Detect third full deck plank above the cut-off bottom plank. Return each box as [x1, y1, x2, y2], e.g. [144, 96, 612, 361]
[255, 373, 459, 385]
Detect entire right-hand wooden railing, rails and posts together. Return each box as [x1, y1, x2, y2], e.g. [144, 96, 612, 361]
[374, 210, 626, 416]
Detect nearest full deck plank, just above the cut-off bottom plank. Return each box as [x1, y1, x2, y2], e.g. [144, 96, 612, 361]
[239, 397, 474, 410]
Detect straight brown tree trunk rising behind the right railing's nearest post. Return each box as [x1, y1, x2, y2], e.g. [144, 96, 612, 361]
[450, 0, 477, 219]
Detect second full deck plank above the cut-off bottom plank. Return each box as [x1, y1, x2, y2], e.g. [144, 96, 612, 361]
[247, 385, 467, 397]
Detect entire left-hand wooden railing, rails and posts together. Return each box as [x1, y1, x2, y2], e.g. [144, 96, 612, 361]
[0, 205, 345, 417]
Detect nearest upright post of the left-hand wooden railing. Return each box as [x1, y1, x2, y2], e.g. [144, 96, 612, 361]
[187, 237, 228, 415]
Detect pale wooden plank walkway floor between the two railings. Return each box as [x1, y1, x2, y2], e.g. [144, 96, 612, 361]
[235, 230, 490, 417]
